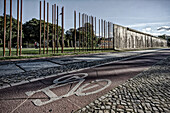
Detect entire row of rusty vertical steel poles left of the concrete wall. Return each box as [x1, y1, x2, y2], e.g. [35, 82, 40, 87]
[3, 0, 113, 56]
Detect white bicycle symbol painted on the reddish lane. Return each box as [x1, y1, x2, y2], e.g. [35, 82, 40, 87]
[25, 73, 111, 106]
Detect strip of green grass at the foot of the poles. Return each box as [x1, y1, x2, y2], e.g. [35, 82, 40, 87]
[0, 48, 167, 60]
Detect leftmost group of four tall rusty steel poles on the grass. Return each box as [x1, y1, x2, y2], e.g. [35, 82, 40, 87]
[3, 0, 22, 57]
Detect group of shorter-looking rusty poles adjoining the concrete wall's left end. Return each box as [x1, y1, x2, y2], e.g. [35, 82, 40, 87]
[74, 11, 114, 52]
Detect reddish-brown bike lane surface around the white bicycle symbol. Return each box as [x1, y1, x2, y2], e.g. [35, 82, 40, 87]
[0, 49, 170, 113]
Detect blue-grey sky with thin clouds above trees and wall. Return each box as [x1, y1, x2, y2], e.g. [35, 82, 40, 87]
[0, 0, 170, 36]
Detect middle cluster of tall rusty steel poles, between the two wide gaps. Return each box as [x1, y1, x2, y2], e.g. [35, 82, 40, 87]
[39, 0, 64, 54]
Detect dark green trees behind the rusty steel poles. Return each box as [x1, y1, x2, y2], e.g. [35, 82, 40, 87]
[0, 15, 96, 47]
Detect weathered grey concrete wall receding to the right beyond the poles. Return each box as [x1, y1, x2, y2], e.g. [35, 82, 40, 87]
[113, 24, 167, 49]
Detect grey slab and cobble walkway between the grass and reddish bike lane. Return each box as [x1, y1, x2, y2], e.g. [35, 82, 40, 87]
[0, 49, 159, 89]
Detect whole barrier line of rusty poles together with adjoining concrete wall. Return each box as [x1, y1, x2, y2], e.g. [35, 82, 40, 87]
[3, 0, 167, 57]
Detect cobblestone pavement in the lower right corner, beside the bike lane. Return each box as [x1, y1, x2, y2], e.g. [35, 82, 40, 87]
[76, 57, 170, 113]
